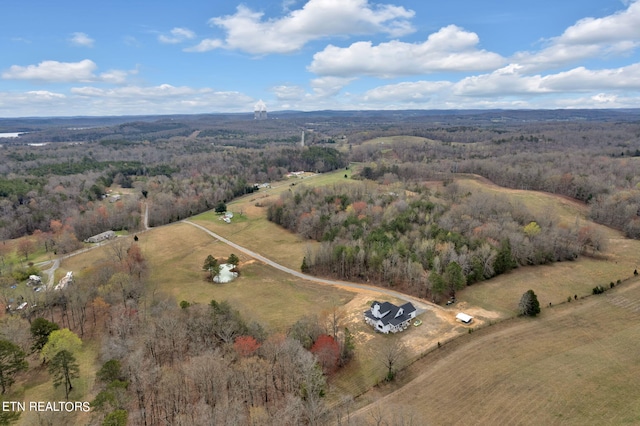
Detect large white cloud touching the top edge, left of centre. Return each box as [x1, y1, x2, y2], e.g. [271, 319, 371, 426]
[191, 0, 414, 55]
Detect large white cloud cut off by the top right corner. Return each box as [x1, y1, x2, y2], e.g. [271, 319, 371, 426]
[511, 1, 640, 72]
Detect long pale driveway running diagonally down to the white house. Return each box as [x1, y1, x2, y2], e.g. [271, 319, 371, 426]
[182, 220, 440, 313]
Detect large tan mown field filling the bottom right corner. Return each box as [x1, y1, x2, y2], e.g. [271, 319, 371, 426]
[352, 279, 640, 425]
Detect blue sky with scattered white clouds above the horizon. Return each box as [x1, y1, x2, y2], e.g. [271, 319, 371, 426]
[0, 0, 640, 117]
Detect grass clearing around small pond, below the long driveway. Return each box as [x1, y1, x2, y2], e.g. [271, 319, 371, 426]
[138, 223, 353, 332]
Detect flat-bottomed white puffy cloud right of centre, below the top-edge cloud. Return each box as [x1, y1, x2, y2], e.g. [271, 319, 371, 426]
[308, 25, 505, 77]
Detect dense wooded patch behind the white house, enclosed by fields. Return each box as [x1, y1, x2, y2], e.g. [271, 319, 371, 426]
[267, 183, 604, 300]
